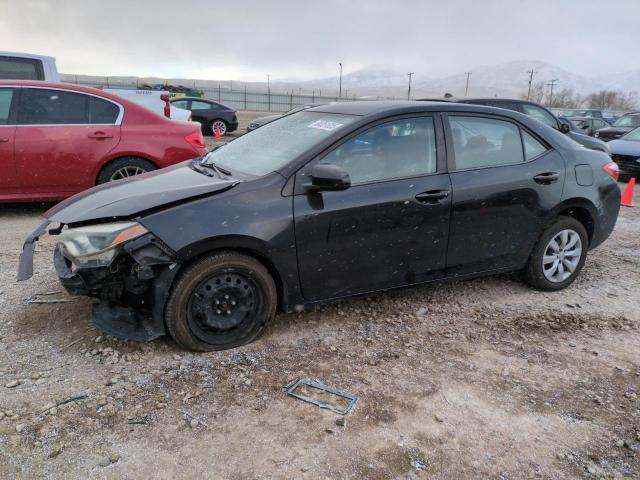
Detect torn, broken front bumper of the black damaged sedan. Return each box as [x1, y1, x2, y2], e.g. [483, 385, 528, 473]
[18, 224, 181, 341]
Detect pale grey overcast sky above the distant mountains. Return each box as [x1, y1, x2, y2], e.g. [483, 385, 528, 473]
[0, 0, 640, 80]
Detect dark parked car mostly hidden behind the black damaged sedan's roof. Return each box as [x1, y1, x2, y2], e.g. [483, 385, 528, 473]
[425, 97, 609, 154]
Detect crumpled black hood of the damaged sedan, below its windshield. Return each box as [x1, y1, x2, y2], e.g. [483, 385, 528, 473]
[44, 160, 239, 224]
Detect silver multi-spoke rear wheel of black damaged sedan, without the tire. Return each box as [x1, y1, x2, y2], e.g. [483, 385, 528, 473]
[542, 229, 582, 283]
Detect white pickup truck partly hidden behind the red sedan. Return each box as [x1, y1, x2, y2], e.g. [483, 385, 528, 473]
[0, 52, 191, 120]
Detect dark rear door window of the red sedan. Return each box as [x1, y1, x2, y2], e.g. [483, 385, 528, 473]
[18, 88, 89, 125]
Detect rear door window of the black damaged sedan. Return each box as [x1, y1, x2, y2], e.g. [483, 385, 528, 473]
[448, 115, 524, 170]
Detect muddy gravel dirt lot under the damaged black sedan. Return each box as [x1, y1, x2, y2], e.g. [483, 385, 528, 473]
[0, 122, 640, 480]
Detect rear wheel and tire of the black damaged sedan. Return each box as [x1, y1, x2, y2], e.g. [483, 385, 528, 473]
[524, 216, 589, 291]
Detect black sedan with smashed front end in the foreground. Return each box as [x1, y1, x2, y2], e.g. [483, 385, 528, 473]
[18, 101, 620, 350]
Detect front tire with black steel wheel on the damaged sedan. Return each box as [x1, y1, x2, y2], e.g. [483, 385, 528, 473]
[165, 252, 277, 352]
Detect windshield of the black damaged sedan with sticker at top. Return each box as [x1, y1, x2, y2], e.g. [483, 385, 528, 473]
[204, 111, 358, 176]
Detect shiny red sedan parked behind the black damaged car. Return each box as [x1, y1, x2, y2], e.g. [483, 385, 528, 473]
[0, 81, 207, 202]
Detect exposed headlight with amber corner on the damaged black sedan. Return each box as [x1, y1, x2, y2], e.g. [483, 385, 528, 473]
[58, 222, 147, 267]
